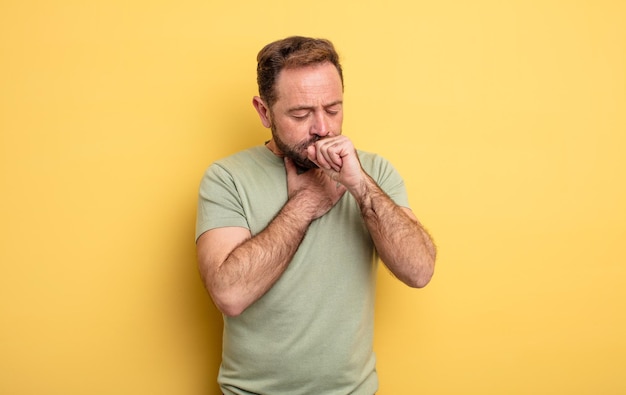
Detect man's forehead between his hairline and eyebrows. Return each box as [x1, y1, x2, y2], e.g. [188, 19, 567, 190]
[275, 63, 343, 104]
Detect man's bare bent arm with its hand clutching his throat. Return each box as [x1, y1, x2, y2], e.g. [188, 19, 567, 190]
[197, 159, 345, 316]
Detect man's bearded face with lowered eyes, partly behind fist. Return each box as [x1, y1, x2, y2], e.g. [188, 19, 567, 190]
[269, 63, 343, 168]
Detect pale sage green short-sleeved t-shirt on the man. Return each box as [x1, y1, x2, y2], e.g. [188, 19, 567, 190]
[196, 146, 408, 395]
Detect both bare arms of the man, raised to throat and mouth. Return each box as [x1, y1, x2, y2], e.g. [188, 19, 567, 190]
[197, 136, 436, 316]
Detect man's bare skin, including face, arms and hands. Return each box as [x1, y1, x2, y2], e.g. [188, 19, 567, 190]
[197, 63, 436, 316]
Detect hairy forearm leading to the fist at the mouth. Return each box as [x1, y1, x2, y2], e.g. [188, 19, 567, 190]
[355, 175, 436, 288]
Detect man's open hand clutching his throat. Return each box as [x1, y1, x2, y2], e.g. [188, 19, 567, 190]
[285, 157, 346, 221]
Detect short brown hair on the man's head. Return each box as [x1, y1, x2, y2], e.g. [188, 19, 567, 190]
[256, 36, 343, 107]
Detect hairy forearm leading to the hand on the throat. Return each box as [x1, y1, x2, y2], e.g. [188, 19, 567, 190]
[208, 195, 311, 315]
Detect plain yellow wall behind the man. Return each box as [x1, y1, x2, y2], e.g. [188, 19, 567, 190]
[0, 0, 626, 395]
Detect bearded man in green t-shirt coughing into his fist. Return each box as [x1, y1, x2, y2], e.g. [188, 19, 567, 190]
[196, 37, 435, 395]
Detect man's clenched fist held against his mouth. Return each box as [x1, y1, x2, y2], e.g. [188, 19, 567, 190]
[307, 136, 366, 195]
